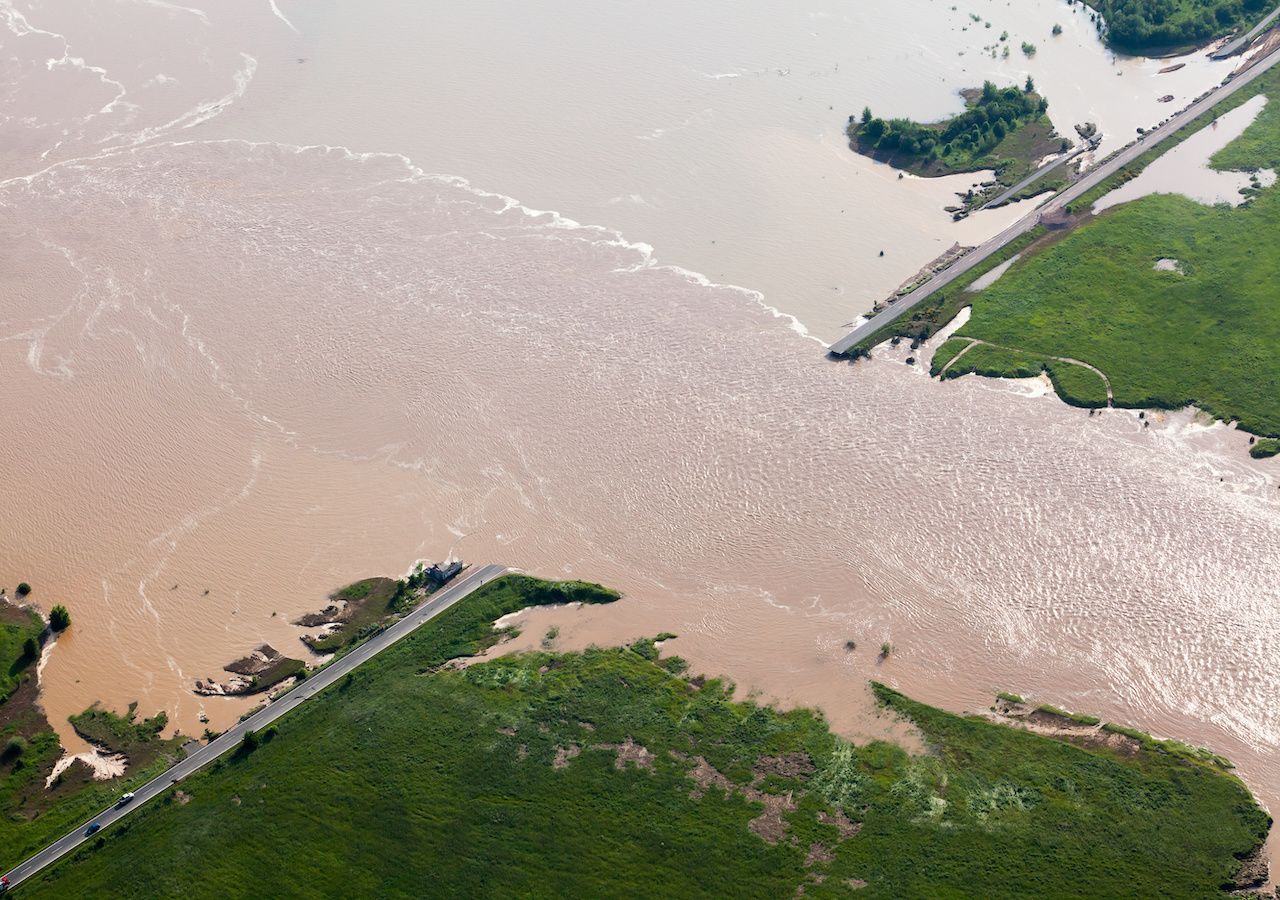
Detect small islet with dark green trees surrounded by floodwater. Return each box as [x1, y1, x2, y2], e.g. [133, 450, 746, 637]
[847, 82, 1066, 206]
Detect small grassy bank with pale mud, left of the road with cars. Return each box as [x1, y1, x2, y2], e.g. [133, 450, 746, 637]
[0, 602, 180, 872]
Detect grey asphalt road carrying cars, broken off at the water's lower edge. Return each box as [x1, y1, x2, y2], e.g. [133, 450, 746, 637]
[8, 566, 508, 886]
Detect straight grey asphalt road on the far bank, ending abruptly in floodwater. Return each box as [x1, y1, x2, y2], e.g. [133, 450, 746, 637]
[828, 40, 1280, 356]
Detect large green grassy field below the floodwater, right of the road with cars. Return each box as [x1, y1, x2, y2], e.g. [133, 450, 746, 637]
[24, 577, 1267, 897]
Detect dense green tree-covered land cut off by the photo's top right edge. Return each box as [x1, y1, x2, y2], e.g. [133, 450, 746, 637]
[1068, 0, 1275, 56]
